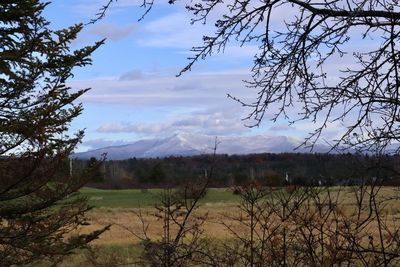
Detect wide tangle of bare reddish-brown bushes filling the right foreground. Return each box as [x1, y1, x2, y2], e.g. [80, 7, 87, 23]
[217, 183, 400, 266]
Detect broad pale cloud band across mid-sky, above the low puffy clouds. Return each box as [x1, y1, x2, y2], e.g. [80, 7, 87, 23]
[70, 70, 256, 108]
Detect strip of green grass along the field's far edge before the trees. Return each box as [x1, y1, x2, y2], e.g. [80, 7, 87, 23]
[80, 187, 239, 208]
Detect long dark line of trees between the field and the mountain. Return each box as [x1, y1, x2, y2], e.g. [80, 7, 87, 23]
[81, 153, 400, 189]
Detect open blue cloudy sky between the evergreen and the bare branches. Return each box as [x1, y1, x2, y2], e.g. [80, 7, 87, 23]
[44, 0, 344, 151]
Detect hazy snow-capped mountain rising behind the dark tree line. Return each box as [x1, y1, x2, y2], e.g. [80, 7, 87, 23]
[74, 133, 328, 160]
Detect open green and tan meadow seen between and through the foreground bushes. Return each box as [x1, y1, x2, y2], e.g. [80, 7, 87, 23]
[32, 187, 400, 267]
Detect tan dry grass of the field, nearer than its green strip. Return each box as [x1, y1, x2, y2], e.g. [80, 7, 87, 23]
[81, 187, 400, 245]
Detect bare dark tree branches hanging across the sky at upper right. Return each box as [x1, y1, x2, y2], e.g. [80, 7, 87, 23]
[96, 0, 400, 152]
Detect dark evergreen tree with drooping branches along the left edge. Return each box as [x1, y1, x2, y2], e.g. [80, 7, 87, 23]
[0, 0, 104, 266]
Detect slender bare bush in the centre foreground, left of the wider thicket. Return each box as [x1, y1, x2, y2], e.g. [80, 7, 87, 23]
[141, 185, 206, 266]
